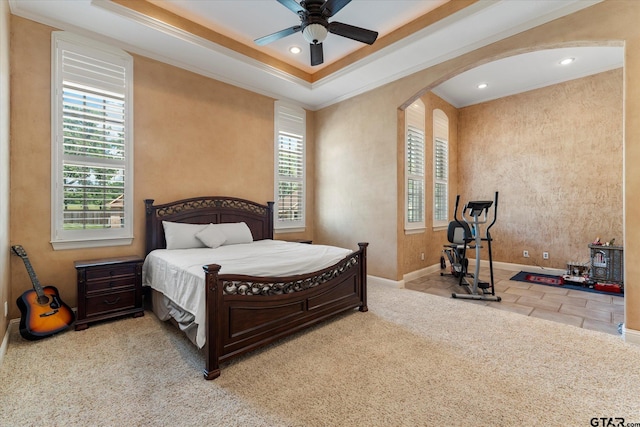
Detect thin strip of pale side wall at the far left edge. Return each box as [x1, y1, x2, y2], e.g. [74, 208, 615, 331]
[0, 0, 14, 342]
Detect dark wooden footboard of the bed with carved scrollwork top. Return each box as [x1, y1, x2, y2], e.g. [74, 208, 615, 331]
[203, 243, 368, 380]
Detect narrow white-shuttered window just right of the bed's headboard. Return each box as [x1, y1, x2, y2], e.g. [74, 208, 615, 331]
[274, 101, 306, 232]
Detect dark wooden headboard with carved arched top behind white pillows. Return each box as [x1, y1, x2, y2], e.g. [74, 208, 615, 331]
[144, 196, 273, 254]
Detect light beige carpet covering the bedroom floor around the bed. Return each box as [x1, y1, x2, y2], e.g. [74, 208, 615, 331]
[0, 280, 640, 426]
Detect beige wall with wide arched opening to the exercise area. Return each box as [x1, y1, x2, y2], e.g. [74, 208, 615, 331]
[316, 0, 640, 332]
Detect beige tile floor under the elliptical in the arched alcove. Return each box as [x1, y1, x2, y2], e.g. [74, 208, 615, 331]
[405, 268, 624, 335]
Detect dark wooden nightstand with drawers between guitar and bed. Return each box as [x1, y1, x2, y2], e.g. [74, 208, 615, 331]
[74, 256, 144, 331]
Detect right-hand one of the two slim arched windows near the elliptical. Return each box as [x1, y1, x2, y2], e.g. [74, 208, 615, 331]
[433, 110, 449, 227]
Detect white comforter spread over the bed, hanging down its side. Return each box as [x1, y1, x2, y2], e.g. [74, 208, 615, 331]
[142, 240, 352, 348]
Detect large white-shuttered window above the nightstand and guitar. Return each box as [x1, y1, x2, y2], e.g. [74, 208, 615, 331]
[51, 31, 133, 249]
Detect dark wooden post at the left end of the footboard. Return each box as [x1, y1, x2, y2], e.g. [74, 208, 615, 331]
[201, 264, 222, 380]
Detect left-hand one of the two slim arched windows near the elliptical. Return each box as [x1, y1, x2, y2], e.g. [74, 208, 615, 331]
[404, 100, 425, 232]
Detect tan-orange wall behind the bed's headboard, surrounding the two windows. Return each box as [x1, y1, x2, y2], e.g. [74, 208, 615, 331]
[3, 16, 314, 318]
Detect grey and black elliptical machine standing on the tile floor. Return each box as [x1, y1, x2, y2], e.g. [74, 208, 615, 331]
[451, 191, 502, 302]
